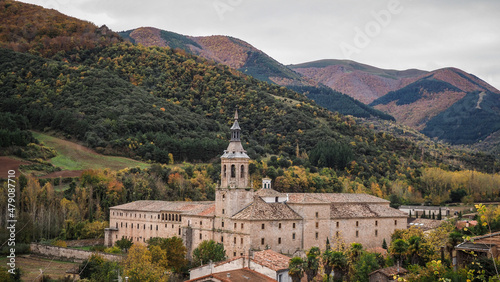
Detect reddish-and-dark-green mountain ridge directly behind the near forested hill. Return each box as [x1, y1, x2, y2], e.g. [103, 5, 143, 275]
[120, 27, 393, 119]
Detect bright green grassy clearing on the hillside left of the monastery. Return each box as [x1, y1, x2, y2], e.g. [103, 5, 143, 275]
[33, 132, 150, 170]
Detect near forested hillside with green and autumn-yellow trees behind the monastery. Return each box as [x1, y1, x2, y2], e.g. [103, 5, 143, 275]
[0, 1, 499, 249]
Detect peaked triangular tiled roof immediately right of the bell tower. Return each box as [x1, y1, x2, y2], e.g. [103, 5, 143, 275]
[232, 196, 302, 220]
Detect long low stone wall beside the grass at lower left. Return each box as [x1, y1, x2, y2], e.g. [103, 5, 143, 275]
[30, 243, 125, 262]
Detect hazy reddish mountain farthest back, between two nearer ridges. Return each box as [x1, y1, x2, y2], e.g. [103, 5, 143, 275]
[288, 60, 426, 104]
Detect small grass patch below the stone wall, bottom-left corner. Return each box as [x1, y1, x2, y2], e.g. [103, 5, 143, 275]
[0, 256, 78, 281]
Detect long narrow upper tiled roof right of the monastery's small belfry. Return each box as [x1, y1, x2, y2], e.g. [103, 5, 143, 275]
[288, 193, 389, 204]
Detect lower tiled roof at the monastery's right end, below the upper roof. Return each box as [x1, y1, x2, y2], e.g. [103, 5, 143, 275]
[330, 203, 407, 218]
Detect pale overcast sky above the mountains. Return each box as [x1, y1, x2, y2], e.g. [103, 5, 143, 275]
[22, 0, 500, 89]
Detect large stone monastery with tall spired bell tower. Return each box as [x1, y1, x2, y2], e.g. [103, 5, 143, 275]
[105, 114, 407, 257]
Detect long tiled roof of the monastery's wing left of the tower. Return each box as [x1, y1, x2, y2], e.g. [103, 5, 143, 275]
[110, 201, 215, 216]
